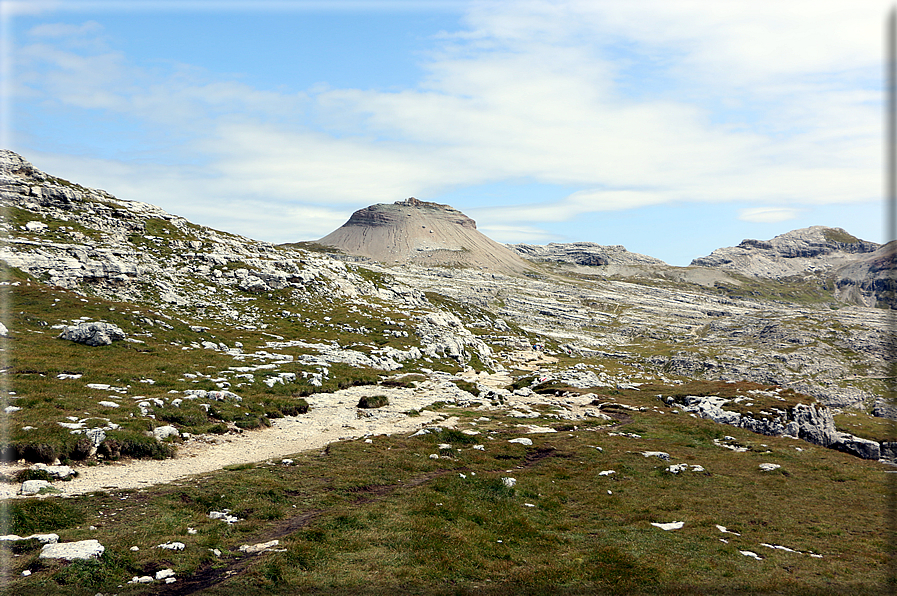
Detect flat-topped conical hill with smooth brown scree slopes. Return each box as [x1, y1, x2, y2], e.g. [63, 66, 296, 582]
[318, 197, 529, 273]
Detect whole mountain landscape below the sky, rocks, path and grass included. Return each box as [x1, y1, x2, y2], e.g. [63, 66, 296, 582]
[0, 151, 897, 594]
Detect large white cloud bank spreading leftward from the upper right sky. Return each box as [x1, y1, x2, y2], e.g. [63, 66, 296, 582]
[10, 0, 886, 244]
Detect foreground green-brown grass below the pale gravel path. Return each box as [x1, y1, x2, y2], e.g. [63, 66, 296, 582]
[6, 411, 887, 594]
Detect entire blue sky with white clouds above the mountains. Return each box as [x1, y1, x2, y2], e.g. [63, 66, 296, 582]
[0, 0, 890, 266]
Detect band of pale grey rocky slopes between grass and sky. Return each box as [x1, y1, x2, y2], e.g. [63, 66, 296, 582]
[0, 151, 893, 434]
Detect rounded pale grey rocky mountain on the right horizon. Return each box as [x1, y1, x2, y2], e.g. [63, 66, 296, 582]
[691, 226, 880, 279]
